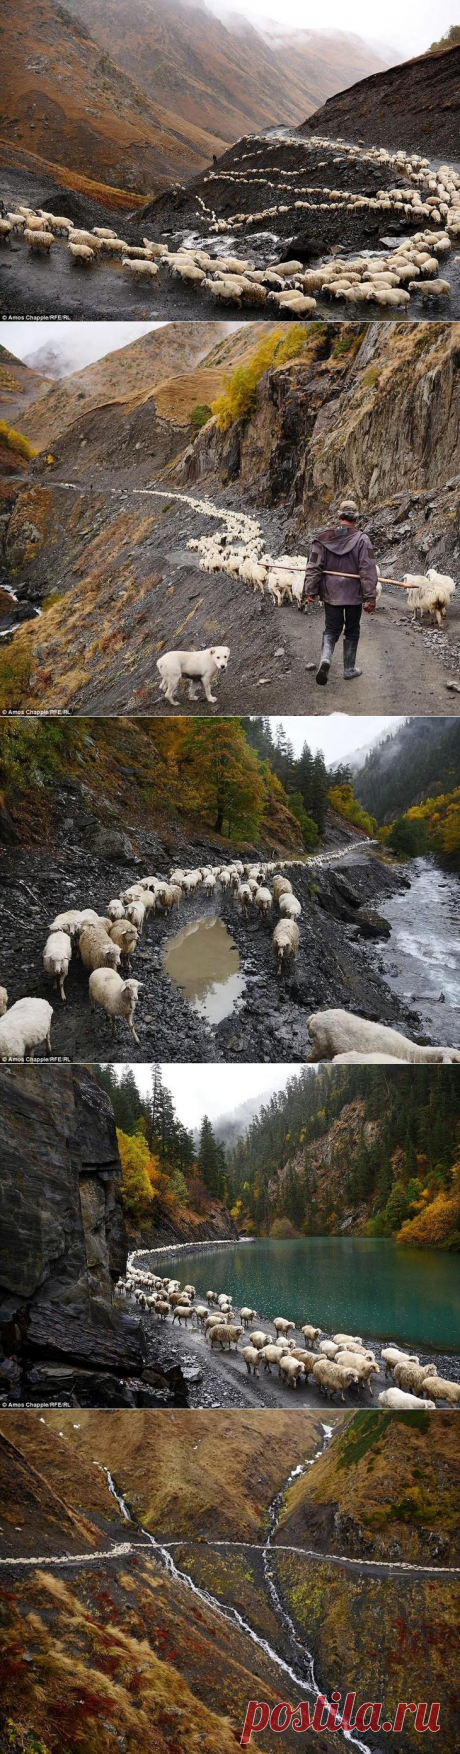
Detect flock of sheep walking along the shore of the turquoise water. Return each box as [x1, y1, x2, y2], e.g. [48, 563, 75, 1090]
[116, 1259, 460, 1410]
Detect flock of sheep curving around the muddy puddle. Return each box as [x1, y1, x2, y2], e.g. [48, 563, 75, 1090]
[0, 847, 460, 1065]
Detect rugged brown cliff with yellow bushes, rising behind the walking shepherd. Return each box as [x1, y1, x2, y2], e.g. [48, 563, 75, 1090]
[181, 323, 460, 528]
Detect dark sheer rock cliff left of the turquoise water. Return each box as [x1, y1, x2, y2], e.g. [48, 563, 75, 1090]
[0, 1066, 144, 1400]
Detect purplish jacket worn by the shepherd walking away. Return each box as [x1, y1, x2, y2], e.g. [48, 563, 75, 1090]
[304, 523, 377, 603]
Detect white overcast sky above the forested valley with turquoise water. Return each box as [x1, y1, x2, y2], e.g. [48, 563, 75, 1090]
[116, 1065, 300, 1128]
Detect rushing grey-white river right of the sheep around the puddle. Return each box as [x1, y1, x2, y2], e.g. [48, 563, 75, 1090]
[370, 859, 460, 1047]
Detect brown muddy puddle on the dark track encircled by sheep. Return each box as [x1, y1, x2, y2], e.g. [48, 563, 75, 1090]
[163, 914, 246, 1024]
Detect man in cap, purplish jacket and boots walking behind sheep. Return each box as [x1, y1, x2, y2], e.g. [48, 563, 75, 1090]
[304, 498, 377, 688]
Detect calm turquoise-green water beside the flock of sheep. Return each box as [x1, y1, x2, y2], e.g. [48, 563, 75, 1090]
[160, 1237, 460, 1354]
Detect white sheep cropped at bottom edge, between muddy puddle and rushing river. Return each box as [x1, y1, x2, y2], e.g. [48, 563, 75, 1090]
[307, 1009, 460, 1065]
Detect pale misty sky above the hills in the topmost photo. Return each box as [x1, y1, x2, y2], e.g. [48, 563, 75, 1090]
[214, 0, 456, 58]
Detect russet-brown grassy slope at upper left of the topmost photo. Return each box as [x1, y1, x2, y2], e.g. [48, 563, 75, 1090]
[2, 0, 225, 200]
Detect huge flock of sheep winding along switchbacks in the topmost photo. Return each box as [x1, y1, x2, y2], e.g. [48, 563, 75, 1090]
[0, 137, 460, 316]
